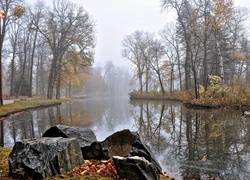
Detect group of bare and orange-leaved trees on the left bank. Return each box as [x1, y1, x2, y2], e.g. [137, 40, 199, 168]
[0, 0, 95, 99]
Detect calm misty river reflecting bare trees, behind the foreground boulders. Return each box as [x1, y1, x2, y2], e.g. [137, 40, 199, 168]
[1, 97, 250, 180]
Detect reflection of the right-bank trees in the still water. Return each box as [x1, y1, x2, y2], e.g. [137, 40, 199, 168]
[132, 101, 250, 179]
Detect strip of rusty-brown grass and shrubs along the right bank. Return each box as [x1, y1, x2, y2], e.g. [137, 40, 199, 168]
[129, 86, 250, 110]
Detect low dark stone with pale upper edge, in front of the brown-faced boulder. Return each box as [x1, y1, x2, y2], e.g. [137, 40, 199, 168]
[112, 156, 160, 180]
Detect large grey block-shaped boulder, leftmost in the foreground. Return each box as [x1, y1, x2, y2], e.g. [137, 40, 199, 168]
[9, 137, 84, 179]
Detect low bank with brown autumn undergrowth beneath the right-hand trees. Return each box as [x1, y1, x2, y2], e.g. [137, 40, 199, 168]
[129, 91, 250, 111]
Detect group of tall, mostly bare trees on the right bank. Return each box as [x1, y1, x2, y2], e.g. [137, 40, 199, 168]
[122, 0, 250, 98]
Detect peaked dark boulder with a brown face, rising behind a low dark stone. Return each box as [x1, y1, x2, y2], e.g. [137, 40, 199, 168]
[103, 129, 162, 173]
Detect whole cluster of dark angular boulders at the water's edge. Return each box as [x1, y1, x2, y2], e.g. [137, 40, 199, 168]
[9, 125, 162, 180]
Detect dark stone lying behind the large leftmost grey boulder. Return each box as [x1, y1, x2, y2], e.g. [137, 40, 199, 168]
[42, 124, 97, 147]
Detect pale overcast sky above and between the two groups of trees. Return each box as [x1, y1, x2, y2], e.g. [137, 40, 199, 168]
[27, 0, 250, 66]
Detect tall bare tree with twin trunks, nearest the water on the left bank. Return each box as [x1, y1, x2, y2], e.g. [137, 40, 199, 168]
[36, 0, 95, 99]
